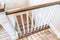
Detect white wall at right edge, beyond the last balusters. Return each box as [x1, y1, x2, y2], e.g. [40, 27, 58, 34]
[50, 5, 60, 32]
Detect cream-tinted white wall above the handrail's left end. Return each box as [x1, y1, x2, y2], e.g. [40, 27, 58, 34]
[4, 0, 26, 9]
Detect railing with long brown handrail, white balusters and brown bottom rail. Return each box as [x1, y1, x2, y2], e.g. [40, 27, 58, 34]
[0, 1, 60, 38]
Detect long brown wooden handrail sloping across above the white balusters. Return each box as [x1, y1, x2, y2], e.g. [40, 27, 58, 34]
[6, 1, 60, 15]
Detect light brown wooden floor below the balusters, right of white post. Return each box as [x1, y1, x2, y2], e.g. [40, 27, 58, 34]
[19, 29, 59, 40]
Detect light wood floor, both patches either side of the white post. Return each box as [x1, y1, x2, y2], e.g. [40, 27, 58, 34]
[0, 27, 58, 40]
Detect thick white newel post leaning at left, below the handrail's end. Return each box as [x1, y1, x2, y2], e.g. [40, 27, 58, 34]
[0, 12, 16, 39]
